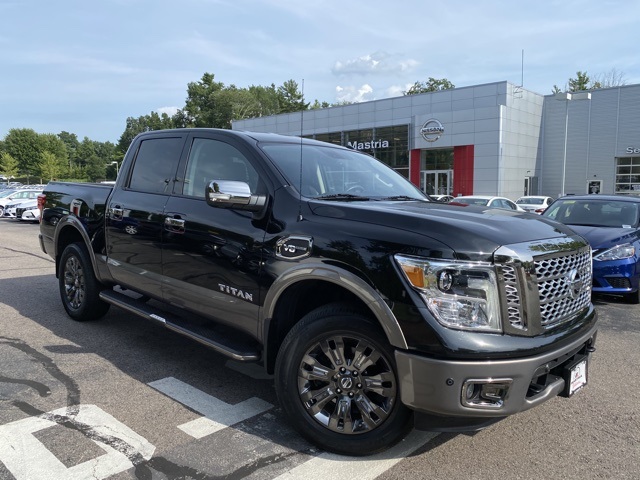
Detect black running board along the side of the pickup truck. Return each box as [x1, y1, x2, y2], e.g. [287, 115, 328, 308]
[100, 290, 261, 362]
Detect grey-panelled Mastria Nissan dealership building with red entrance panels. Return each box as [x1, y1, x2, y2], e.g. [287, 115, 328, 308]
[233, 82, 640, 200]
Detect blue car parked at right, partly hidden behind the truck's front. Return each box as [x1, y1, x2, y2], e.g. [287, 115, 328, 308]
[542, 195, 640, 304]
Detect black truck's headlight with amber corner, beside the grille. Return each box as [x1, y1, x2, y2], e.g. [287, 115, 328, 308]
[394, 255, 502, 332]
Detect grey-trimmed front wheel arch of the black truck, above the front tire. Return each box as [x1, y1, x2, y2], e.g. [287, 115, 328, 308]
[260, 264, 407, 373]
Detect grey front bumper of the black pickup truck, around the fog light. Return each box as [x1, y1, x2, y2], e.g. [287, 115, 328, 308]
[395, 323, 597, 428]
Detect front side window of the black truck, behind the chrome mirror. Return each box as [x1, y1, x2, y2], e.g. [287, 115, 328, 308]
[182, 138, 258, 197]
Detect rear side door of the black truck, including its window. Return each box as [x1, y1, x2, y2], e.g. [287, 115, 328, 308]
[105, 133, 187, 298]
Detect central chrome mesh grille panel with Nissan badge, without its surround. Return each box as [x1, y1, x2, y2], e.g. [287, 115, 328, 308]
[534, 251, 591, 327]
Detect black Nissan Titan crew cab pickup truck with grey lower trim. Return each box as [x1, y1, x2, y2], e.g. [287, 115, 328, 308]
[40, 129, 597, 455]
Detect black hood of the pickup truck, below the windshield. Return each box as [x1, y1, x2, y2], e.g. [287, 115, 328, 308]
[309, 201, 575, 261]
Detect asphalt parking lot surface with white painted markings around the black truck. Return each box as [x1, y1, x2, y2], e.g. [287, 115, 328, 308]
[0, 219, 640, 480]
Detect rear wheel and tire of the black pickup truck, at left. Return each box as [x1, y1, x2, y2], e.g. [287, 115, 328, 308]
[58, 243, 110, 322]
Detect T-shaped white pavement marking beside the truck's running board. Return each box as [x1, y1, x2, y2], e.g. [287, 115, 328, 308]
[149, 377, 273, 438]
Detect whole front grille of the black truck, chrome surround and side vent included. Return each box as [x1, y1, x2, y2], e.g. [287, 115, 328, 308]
[495, 237, 592, 335]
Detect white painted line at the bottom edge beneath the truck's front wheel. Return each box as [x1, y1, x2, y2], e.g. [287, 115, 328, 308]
[274, 430, 438, 480]
